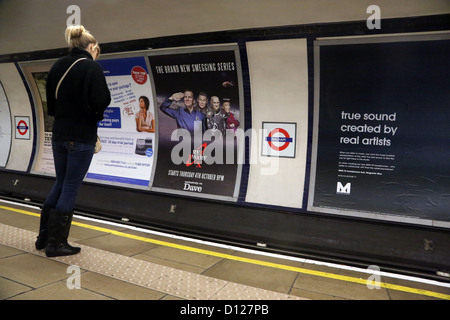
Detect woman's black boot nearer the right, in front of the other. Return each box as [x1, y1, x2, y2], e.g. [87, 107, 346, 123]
[45, 210, 81, 257]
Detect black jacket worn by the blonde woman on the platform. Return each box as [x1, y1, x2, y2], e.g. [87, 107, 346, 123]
[46, 48, 111, 144]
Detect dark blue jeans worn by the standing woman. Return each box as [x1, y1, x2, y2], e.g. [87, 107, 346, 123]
[45, 141, 95, 213]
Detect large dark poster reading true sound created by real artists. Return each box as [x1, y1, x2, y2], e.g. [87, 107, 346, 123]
[310, 38, 450, 221]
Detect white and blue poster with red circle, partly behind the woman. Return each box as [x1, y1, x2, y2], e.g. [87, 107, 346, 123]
[86, 57, 156, 187]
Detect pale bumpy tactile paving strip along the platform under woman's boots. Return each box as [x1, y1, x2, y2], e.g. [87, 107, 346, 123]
[0, 224, 302, 300]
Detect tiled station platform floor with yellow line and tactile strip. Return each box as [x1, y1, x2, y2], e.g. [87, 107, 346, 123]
[0, 201, 450, 301]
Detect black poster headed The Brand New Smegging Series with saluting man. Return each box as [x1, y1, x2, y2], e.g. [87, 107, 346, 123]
[149, 47, 243, 199]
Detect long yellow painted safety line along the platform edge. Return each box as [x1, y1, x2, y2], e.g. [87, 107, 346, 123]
[0, 206, 450, 300]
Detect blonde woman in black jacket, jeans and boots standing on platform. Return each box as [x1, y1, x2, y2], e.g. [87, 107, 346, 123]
[35, 26, 111, 257]
